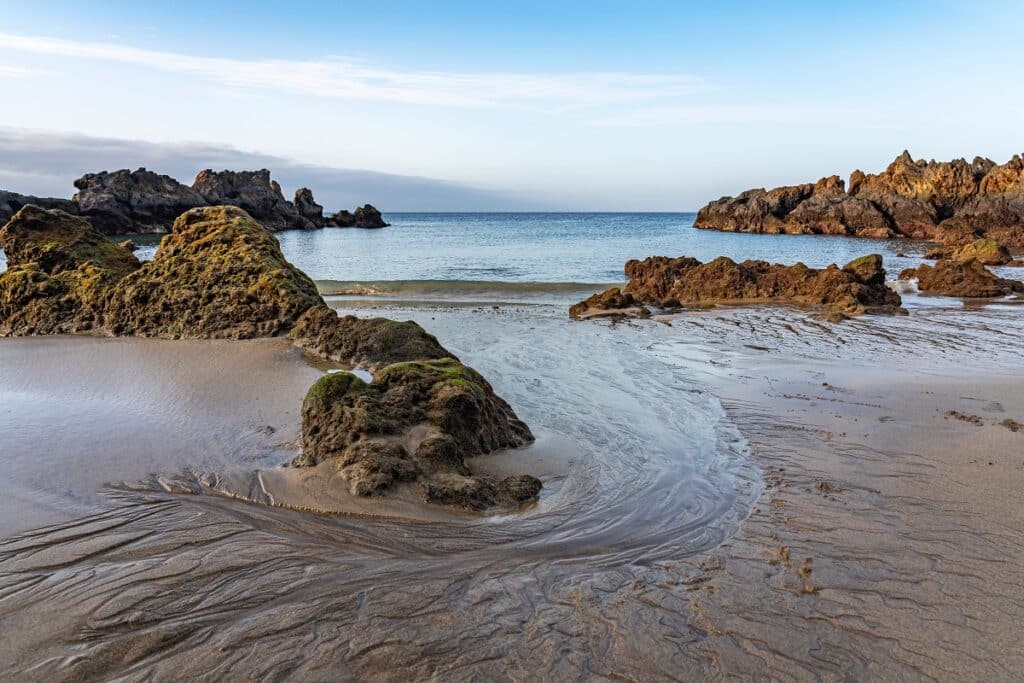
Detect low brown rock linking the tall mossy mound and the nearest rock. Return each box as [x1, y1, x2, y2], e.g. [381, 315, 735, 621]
[290, 304, 455, 368]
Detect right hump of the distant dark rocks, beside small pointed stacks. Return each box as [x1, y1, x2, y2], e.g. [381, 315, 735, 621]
[193, 169, 318, 230]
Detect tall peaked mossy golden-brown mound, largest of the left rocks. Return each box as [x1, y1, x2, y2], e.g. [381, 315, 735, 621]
[106, 206, 323, 339]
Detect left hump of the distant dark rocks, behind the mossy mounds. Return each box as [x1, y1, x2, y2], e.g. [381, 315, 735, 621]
[72, 168, 207, 234]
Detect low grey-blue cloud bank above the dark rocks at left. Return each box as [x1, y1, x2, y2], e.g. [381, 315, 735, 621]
[0, 127, 551, 212]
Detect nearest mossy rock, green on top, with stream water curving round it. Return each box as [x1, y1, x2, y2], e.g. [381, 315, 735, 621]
[294, 358, 539, 509]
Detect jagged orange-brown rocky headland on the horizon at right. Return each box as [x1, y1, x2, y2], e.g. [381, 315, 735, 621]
[694, 152, 1024, 248]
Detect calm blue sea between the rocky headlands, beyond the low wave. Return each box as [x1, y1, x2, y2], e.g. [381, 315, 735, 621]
[0, 213, 942, 284]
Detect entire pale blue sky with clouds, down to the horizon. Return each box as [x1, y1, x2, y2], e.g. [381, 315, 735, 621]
[0, 0, 1024, 211]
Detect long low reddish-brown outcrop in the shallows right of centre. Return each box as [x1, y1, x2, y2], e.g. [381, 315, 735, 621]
[574, 254, 905, 319]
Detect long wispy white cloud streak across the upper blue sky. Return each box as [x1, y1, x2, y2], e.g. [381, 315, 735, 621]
[0, 33, 707, 109]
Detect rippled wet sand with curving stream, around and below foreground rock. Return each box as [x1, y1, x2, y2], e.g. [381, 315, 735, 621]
[0, 300, 1024, 680]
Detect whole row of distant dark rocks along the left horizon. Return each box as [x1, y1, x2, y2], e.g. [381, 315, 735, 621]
[0, 168, 387, 236]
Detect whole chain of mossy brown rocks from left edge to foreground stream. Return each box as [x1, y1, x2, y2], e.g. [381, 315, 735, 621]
[0, 206, 541, 509]
